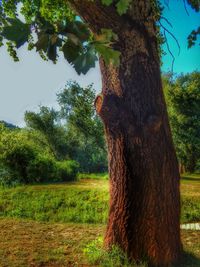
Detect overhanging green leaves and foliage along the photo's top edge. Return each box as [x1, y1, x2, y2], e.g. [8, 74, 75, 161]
[0, 0, 199, 74]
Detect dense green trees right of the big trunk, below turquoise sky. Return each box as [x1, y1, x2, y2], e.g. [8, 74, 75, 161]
[164, 72, 200, 172]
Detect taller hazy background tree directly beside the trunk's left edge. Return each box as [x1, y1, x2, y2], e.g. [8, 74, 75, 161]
[57, 82, 107, 172]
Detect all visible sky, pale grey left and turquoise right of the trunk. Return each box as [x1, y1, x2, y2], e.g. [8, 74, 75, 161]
[0, 0, 200, 127]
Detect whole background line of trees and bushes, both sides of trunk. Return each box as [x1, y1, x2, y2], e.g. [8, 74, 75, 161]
[0, 72, 200, 187]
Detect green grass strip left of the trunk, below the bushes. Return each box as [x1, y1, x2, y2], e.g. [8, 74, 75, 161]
[0, 183, 108, 223]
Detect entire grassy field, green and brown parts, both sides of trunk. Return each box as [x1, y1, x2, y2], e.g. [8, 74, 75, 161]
[0, 175, 200, 267]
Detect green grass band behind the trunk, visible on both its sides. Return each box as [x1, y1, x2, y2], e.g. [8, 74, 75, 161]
[0, 176, 200, 224]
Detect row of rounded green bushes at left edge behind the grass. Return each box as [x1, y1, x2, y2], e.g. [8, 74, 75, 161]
[0, 127, 79, 185]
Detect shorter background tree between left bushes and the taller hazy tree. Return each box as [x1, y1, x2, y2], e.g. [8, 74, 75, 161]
[24, 106, 68, 160]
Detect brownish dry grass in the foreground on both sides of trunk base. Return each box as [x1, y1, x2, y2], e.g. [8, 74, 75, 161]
[0, 219, 200, 267]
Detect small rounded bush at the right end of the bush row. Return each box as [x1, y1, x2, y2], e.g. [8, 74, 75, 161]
[56, 160, 79, 182]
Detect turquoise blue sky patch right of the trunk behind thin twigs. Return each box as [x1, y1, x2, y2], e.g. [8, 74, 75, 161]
[161, 0, 200, 73]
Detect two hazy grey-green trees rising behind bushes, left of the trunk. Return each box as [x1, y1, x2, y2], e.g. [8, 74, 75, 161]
[25, 82, 107, 172]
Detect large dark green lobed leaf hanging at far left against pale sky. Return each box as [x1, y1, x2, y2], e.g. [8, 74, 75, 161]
[1, 18, 31, 48]
